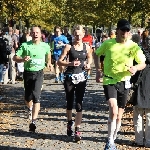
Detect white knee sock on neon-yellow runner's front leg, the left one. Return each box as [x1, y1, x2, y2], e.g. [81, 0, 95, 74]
[108, 118, 116, 144]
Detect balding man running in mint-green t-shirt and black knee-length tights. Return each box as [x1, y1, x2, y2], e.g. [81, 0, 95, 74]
[13, 27, 52, 132]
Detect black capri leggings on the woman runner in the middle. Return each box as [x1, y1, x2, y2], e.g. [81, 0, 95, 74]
[64, 78, 86, 112]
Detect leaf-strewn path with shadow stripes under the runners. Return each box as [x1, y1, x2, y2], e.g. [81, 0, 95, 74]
[0, 69, 148, 150]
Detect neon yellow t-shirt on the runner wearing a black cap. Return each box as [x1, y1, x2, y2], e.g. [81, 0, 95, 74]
[95, 39, 146, 85]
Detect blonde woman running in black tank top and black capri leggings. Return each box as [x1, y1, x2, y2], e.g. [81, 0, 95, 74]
[58, 25, 92, 142]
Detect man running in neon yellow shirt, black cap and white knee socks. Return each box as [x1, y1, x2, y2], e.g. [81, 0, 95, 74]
[94, 19, 146, 150]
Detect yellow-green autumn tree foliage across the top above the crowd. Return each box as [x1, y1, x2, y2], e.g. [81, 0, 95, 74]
[0, 0, 150, 30]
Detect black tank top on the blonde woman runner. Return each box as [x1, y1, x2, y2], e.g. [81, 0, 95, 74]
[65, 44, 87, 74]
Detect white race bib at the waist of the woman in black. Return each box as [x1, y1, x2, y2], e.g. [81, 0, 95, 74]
[71, 73, 86, 84]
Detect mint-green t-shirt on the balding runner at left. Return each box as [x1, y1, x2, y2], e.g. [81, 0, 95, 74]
[16, 41, 50, 71]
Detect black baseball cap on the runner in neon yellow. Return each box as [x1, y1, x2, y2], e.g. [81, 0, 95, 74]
[117, 19, 131, 30]
